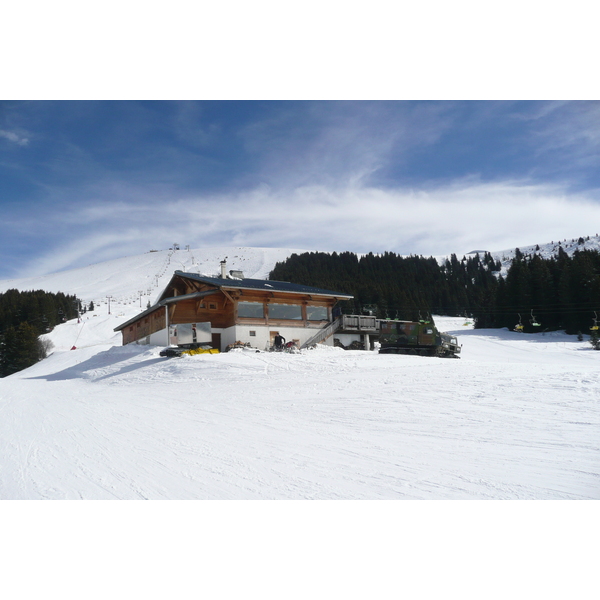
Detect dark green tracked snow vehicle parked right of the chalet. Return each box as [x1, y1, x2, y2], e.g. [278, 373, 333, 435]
[379, 320, 461, 358]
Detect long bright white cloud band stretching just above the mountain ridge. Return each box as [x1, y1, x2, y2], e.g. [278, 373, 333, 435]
[15, 179, 600, 274]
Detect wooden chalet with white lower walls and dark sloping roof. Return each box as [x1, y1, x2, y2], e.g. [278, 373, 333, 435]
[115, 262, 353, 351]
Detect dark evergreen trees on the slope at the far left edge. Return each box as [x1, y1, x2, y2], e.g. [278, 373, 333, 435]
[0, 289, 81, 377]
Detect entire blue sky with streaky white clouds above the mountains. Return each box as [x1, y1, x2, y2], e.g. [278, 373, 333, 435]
[0, 100, 600, 279]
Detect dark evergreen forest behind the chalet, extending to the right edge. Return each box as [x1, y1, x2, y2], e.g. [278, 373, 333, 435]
[270, 248, 600, 333]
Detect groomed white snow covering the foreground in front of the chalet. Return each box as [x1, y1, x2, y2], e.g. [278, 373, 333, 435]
[0, 313, 600, 499]
